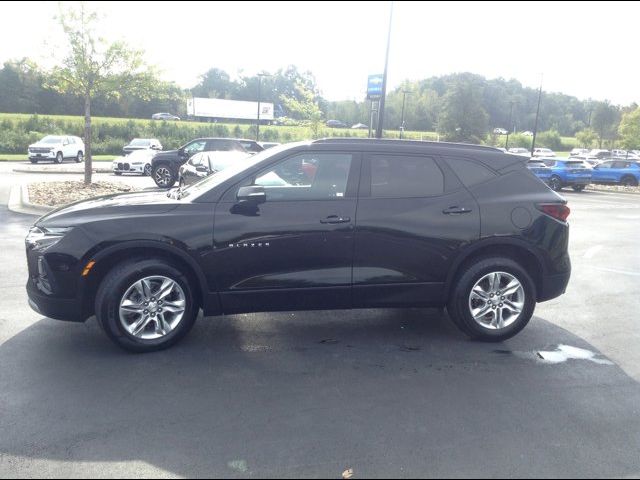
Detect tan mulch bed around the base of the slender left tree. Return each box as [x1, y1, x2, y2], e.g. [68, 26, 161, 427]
[29, 180, 139, 207]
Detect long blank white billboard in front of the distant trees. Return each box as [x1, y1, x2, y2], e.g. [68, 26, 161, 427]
[187, 97, 273, 120]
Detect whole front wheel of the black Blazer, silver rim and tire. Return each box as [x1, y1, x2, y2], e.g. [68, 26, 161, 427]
[95, 258, 199, 352]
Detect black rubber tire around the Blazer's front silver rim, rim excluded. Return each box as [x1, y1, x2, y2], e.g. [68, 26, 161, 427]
[95, 258, 199, 353]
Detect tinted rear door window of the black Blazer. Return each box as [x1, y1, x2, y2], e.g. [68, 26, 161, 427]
[371, 155, 444, 198]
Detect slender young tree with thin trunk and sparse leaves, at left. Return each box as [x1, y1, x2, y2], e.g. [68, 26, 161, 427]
[47, 2, 155, 185]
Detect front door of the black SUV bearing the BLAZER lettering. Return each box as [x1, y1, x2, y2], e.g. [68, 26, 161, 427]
[214, 154, 359, 313]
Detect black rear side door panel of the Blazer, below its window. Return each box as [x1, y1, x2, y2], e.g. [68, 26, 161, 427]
[353, 157, 480, 307]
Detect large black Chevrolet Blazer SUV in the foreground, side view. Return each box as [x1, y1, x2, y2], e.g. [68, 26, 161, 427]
[26, 139, 571, 351]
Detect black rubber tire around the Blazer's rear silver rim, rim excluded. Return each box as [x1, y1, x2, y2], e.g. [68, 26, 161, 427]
[447, 257, 536, 342]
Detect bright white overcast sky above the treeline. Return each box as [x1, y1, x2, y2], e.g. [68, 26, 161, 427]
[0, 1, 640, 104]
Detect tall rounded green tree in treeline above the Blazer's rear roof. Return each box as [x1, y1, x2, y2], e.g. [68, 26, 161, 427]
[438, 77, 488, 143]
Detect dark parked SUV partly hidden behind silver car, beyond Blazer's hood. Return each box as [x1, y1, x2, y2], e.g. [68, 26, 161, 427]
[151, 138, 249, 188]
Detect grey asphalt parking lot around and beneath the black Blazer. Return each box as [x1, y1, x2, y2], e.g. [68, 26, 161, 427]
[0, 166, 640, 478]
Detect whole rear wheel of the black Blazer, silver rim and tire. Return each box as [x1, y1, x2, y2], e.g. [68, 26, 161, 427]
[447, 257, 536, 342]
